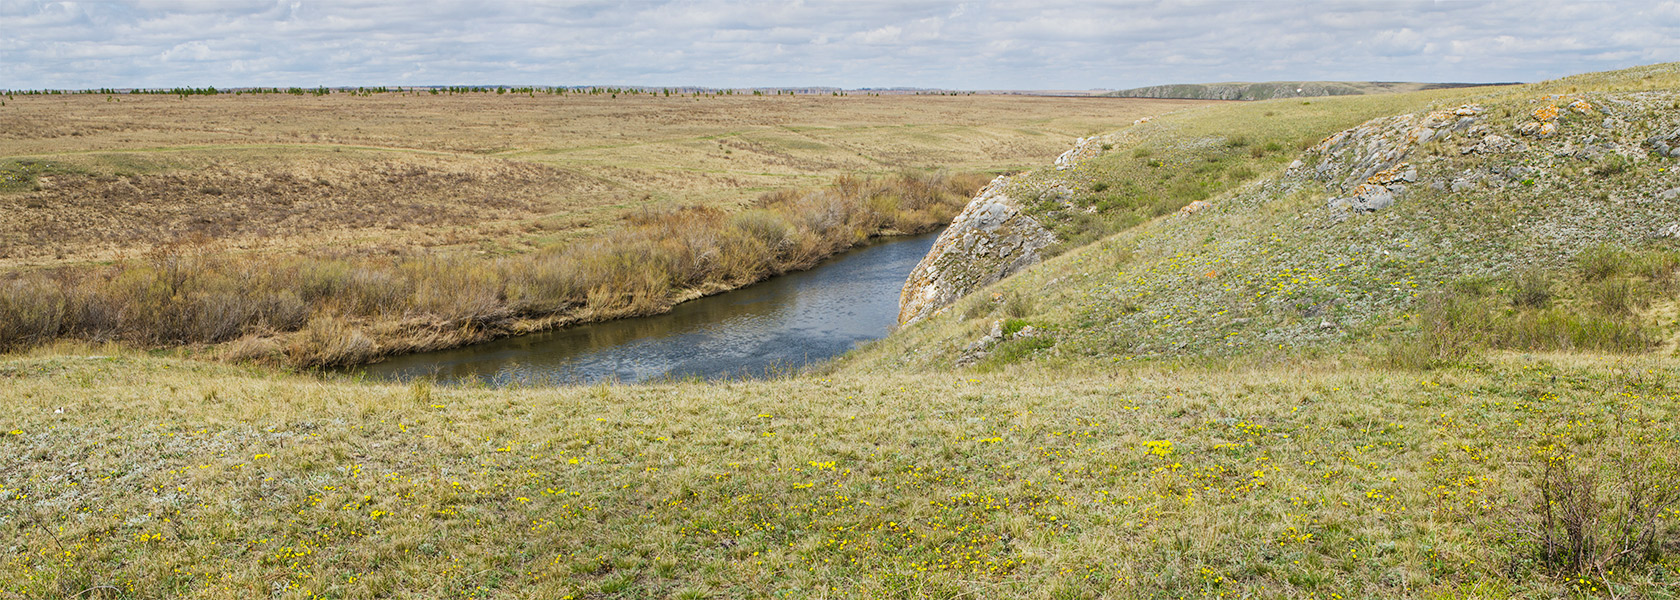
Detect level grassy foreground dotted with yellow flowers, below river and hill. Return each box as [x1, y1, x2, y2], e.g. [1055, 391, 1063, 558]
[0, 347, 1680, 598]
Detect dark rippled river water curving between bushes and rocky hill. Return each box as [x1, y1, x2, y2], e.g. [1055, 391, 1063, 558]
[346, 232, 939, 385]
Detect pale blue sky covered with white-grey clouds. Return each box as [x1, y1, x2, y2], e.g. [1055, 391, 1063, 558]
[0, 0, 1680, 89]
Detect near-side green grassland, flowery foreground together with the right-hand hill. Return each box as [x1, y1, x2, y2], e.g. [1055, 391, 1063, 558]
[0, 64, 1680, 598]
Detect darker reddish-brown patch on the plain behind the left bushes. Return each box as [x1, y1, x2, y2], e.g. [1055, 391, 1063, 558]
[0, 156, 593, 261]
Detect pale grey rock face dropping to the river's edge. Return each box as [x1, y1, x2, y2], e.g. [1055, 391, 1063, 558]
[899, 176, 1055, 324]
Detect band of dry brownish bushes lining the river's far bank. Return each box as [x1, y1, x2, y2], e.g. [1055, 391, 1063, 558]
[0, 173, 986, 366]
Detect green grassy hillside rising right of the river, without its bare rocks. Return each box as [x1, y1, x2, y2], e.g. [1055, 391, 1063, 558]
[858, 66, 1680, 376]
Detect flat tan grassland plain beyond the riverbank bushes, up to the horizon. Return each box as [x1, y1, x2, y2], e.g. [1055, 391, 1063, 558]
[0, 92, 1205, 267]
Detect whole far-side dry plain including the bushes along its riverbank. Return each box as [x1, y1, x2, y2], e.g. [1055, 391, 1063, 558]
[0, 92, 1193, 365]
